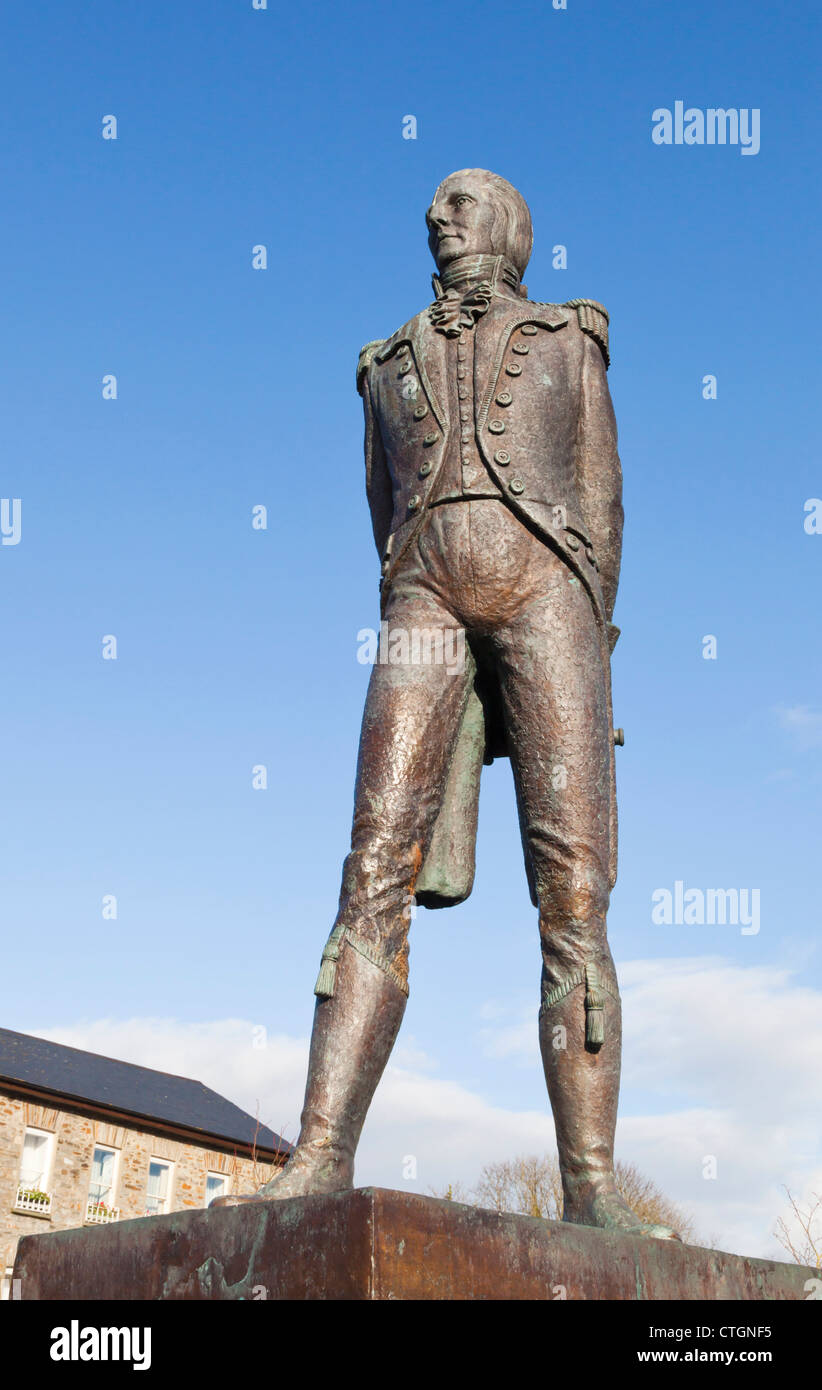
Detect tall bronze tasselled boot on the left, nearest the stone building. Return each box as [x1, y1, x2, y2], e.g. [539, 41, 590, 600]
[211, 940, 408, 1207]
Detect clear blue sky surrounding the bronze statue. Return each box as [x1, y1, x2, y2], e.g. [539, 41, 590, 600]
[0, 0, 822, 1252]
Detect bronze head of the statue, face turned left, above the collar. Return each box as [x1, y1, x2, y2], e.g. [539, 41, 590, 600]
[426, 170, 534, 278]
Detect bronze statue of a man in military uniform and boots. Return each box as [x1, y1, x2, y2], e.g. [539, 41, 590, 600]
[220, 170, 676, 1238]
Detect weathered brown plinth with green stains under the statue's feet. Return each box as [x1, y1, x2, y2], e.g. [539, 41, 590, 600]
[14, 1187, 812, 1301]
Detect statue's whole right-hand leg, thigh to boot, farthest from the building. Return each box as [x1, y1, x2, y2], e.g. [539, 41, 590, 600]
[495, 567, 677, 1238]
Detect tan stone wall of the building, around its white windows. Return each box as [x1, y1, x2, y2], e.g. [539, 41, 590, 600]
[0, 1090, 274, 1277]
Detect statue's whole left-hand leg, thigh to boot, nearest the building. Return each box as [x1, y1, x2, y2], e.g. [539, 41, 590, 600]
[211, 595, 474, 1207]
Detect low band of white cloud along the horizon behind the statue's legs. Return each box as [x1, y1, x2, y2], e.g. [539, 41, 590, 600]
[40, 958, 822, 1258]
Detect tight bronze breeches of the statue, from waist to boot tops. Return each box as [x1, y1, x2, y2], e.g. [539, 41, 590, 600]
[328, 499, 616, 1002]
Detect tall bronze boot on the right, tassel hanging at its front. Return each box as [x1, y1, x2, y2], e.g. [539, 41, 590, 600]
[540, 966, 682, 1240]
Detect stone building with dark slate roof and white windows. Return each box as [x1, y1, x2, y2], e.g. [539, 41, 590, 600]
[0, 1029, 291, 1294]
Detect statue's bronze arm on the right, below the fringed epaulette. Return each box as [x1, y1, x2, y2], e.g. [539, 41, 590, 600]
[576, 322, 623, 633]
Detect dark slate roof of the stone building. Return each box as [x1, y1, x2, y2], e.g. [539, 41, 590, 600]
[0, 1029, 292, 1152]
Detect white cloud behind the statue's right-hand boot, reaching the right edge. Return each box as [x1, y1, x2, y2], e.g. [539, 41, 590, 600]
[483, 956, 822, 1258]
